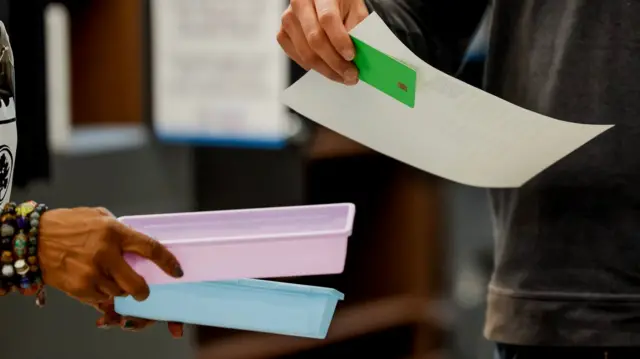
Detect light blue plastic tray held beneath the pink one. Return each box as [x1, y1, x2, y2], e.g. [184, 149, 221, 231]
[115, 279, 344, 339]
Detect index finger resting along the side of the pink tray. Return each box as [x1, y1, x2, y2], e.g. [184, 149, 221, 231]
[114, 221, 184, 278]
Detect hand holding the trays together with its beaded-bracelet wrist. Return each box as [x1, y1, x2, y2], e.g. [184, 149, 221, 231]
[0, 201, 184, 337]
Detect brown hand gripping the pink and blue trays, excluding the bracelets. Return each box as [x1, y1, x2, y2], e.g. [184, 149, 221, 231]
[38, 208, 183, 303]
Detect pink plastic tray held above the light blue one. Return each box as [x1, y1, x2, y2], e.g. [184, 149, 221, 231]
[120, 203, 355, 284]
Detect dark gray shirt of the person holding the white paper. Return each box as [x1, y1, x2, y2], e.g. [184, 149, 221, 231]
[369, 0, 640, 346]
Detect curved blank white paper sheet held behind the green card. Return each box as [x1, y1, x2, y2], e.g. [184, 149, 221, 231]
[282, 13, 613, 188]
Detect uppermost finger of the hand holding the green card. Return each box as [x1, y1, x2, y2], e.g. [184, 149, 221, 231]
[315, 0, 356, 61]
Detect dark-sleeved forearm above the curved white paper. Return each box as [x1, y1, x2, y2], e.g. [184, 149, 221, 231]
[365, 0, 489, 74]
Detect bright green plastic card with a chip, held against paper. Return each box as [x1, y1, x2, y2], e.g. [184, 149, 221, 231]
[351, 36, 417, 108]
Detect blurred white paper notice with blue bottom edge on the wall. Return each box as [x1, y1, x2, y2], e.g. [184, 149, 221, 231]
[150, 0, 293, 147]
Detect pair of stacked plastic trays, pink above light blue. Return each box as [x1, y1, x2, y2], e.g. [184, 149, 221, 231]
[115, 204, 355, 339]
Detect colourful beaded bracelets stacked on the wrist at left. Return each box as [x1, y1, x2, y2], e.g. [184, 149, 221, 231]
[0, 201, 48, 306]
